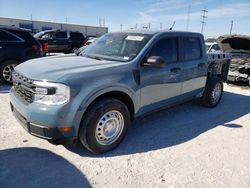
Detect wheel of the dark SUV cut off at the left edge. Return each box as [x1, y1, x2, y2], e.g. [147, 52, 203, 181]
[0, 60, 20, 85]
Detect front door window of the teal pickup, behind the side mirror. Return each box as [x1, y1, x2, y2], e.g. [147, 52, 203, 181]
[149, 37, 178, 63]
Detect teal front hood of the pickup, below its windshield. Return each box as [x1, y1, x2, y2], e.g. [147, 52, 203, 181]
[15, 55, 125, 81]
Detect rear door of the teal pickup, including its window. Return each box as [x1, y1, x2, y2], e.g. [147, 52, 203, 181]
[181, 36, 207, 97]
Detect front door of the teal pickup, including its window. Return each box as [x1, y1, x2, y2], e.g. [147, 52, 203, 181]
[140, 37, 183, 113]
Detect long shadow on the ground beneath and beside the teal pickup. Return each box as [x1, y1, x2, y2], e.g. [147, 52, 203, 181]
[68, 92, 250, 157]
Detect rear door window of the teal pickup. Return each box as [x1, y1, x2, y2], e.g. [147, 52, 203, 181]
[183, 37, 202, 60]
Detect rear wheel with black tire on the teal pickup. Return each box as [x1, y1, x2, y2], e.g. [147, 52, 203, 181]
[201, 77, 223, 108]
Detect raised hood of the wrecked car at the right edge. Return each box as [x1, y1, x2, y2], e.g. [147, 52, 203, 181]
[217, 35, 250, 53]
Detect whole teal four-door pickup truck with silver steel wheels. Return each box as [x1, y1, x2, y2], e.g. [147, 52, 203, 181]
[10, 31, 230, 153]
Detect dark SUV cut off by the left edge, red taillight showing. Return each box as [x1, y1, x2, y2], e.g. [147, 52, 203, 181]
[0, 26, 41, 84]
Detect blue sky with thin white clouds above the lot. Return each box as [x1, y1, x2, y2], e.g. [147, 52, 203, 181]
[0, 0, 250, 37]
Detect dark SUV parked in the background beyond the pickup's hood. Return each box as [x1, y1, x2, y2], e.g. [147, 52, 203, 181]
[34, 30, 85, 53]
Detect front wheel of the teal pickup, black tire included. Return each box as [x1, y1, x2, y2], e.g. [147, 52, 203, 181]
[79, 98, 130, 154]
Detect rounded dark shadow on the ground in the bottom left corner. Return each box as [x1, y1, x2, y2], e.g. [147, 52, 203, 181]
[0, 147, 91, 188]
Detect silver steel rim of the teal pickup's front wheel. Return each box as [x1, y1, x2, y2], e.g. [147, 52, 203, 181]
[95, 110, 124, 145]
